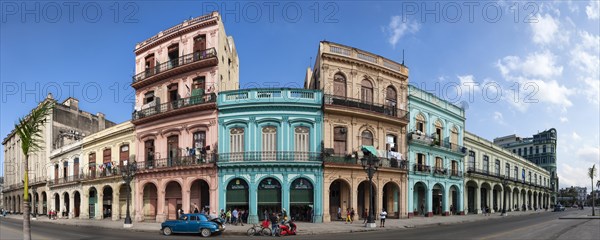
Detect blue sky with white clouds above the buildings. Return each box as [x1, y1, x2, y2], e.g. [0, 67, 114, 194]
[0, 0, 600, 187]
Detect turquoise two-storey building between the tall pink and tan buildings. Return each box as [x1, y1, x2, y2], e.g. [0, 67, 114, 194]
[217, 89, 323, 223]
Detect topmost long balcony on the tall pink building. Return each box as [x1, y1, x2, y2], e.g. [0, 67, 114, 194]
[131, 48, 219, 89]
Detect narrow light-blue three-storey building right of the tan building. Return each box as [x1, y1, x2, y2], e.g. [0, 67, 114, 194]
[407, 86, 466, 217]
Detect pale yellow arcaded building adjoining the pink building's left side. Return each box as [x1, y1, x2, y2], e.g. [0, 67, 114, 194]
[79, 121, 136, 220]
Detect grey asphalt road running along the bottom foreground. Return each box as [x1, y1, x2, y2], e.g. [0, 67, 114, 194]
[0, 209, 600, 240]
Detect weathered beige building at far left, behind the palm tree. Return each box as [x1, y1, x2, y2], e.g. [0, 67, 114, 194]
[2, 94, 115, 214]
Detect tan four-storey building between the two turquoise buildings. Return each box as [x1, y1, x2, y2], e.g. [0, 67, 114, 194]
[305, 41, 408, 221]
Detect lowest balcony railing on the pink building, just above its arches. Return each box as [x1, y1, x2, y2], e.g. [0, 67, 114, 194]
[137, 154, 216, 170]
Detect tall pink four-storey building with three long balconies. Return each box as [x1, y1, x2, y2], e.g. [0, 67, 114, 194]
[131, 12, 239, 222]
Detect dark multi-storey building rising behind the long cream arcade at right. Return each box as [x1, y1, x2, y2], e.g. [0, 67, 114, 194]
[494, 128, 558, 204]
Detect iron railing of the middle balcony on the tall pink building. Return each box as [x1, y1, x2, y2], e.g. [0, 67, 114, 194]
[132, 93, 217, 120]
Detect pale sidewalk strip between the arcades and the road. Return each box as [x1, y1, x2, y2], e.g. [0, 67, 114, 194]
[6, 209, 560, 235]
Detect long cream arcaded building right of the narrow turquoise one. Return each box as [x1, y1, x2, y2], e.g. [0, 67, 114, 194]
[464, 132, 552, 213]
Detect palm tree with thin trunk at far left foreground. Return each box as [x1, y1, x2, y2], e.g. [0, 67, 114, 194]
[15, 101, 52, 240]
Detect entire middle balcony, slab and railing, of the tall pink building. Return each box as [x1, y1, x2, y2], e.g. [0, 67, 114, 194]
[132, 93, 217, 124]
